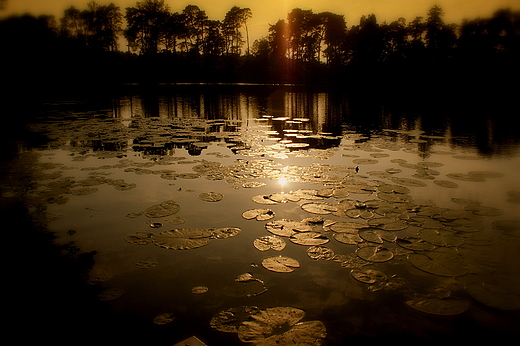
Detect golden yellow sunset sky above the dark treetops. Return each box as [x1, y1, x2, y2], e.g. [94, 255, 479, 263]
[0, 0, 520, 40]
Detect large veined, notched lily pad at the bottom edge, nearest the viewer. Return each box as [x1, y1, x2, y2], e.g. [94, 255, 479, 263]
[238, 307, 326, 346]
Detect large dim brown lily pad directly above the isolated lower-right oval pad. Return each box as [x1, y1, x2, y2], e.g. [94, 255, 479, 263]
[408, 248, 468, 277]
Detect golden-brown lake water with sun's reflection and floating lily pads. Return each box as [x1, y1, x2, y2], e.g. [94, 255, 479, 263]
[3, 85, 520, 345]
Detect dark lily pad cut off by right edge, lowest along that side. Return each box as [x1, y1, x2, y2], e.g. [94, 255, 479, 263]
[466, 282, 520, 310]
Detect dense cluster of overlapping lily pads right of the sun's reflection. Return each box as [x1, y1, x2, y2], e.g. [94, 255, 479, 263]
[242, 181, 520, 315]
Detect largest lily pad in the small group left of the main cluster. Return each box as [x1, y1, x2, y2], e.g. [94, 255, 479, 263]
[153, 228, 212, 250]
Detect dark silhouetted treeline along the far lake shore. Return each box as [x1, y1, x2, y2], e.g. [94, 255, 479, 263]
[0, 0, 520, 89]
